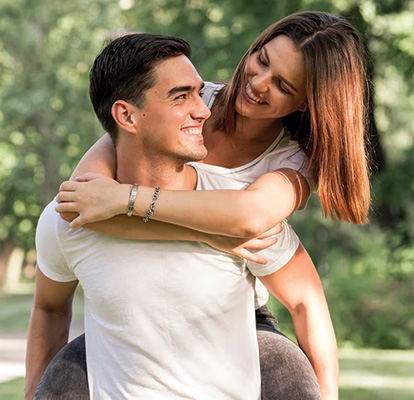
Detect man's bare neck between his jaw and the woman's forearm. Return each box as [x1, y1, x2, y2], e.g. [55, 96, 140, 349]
[116, 149, 197, 190]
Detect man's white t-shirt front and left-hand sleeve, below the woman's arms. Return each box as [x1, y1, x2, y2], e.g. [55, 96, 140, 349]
[36, 196, 292, 400]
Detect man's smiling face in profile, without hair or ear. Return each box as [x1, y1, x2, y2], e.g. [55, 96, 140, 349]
[136, 56, 210, 162]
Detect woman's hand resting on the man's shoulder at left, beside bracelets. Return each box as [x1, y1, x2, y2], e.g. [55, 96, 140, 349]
[55, 173, 131, 228]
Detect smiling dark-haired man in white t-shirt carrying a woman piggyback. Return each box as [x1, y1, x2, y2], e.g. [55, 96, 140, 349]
[26, 34, 336, 400]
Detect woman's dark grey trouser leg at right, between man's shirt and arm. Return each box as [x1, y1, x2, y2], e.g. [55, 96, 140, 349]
[256, 307, 321, 400]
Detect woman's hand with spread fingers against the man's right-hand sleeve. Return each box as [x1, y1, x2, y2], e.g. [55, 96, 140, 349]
[203, 224, 282, 265]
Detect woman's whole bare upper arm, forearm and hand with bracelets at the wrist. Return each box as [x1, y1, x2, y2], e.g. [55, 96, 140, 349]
[56, 169, 310, 237]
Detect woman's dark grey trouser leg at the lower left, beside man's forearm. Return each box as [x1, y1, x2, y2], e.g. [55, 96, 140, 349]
[34, 335, 89, 400]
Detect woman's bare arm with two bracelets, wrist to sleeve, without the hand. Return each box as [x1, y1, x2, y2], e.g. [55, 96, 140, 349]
[133, 169, 310, 237]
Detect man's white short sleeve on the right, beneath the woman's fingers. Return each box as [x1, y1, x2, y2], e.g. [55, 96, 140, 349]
[247, 220, 300, 276]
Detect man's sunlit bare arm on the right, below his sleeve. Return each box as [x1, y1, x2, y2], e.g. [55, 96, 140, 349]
[260, 245, 339, 400]
